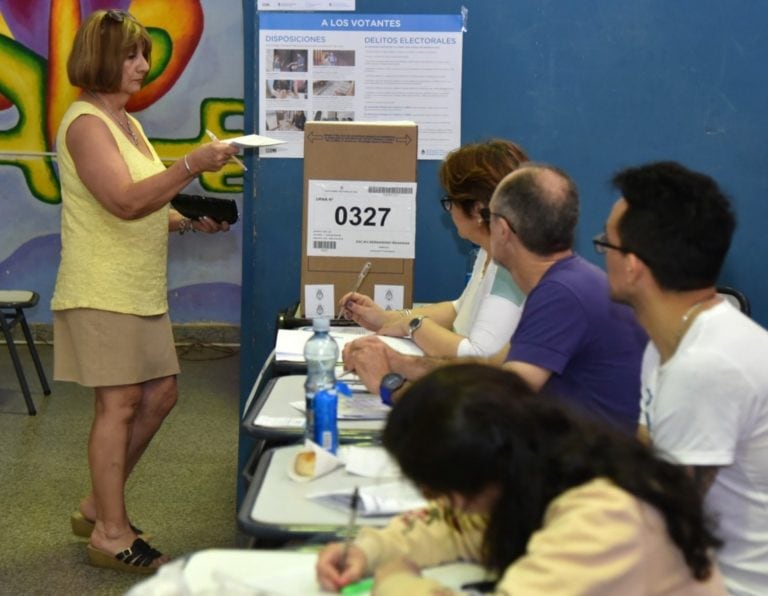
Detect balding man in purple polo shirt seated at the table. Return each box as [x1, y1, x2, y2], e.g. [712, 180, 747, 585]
[344, 164, 647, 433]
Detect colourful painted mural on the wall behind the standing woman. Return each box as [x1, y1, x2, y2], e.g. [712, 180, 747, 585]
[0, 0, 243, 324]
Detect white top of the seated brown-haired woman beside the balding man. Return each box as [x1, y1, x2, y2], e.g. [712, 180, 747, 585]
[453, 248, 525, 357]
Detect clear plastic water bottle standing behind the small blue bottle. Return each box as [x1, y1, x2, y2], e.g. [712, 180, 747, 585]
[304, 318, 339, 441]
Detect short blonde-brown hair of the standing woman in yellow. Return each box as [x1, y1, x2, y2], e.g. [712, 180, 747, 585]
[67, 9, 152, 93]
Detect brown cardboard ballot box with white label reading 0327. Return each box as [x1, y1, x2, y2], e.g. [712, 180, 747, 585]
[300, 122, 417, 317]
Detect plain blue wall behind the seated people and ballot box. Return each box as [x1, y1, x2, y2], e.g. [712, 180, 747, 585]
[242, 0, 768, 392]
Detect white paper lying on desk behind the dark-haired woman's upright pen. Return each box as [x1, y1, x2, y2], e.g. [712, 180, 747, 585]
[307, 480, 427, 517]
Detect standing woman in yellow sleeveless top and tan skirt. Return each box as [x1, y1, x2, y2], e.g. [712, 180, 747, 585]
[51, 10, 236, 573]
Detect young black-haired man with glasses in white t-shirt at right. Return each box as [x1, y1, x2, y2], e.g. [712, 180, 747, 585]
[594, 162, 768, 595]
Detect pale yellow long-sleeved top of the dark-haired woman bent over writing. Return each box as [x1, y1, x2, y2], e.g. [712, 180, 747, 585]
[356, 479, 726, 596]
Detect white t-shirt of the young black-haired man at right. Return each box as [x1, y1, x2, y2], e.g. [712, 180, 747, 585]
[640, 301, 768, 595]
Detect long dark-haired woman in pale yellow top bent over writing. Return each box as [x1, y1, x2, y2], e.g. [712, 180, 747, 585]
[317, 364, 726, 596]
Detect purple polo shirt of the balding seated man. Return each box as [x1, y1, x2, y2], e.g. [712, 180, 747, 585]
[507, 255, 648, 433]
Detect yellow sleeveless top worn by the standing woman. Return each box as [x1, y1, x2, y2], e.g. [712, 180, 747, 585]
[51, 101, 168, 316]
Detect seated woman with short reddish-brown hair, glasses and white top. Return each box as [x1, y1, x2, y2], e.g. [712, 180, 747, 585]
[340, 139, 528, 361]
